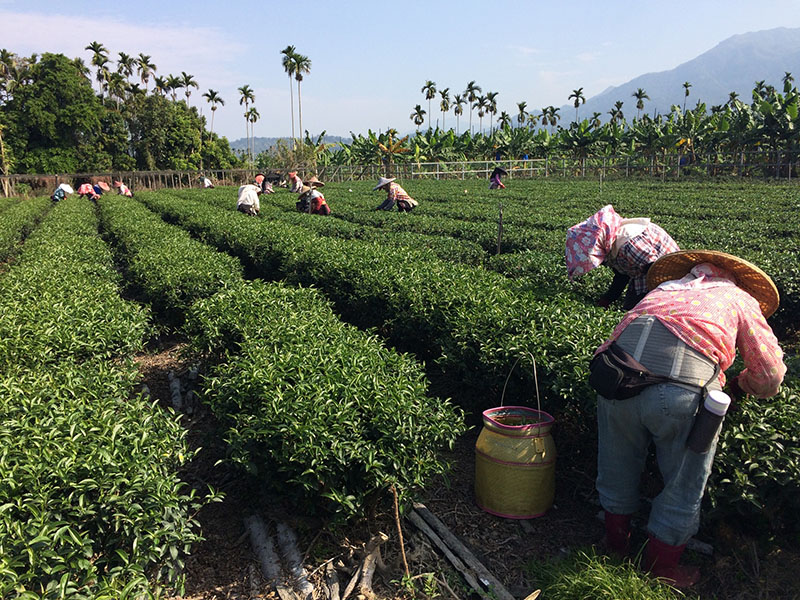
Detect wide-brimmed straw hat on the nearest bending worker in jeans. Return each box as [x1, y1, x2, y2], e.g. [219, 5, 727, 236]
[647, 250, 780, 317]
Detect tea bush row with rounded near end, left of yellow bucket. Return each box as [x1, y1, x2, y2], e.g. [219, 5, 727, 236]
[98, 198, 464, 517]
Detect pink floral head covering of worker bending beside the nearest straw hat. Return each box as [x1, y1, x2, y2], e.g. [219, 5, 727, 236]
[564, 204, 622, 280]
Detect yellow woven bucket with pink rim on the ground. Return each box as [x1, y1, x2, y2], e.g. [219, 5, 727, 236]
[475, 406, 556, 519]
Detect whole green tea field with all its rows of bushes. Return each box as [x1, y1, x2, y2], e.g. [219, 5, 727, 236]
[0, 180, 800, 598]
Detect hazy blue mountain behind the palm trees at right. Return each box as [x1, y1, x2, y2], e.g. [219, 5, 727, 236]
[560, 27, 800, 122]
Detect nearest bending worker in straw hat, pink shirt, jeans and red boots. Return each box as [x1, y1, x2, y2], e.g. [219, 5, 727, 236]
[592, 250, 786, 587]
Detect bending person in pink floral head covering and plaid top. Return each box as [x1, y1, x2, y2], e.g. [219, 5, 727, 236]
[565, 204, 678, 310]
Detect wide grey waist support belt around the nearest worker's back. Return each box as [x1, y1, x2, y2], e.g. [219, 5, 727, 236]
[617, 315, 721, 390]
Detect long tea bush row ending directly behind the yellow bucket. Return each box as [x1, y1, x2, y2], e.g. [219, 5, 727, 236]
[141, 192, 615, 409]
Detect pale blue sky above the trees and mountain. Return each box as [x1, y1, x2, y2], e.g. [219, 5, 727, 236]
[0, 0, 800, 141]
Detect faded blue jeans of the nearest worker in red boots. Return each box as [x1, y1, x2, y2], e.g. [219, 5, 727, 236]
[597, 383, 717, 546]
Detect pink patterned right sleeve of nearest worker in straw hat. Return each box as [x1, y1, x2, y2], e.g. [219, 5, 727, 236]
[736, 301, 786, 398]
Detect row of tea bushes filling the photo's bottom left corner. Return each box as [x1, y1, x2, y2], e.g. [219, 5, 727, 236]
[0, 198, 203, 599]
